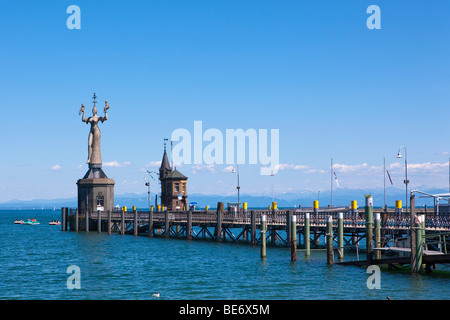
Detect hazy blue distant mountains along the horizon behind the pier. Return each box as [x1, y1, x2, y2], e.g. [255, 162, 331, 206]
[0, 188, 448, 210]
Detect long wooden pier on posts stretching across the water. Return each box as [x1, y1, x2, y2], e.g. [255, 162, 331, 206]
[62, 199, 450, 274]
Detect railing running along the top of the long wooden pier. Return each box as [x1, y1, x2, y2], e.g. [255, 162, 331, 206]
[68, 207, 450, 231]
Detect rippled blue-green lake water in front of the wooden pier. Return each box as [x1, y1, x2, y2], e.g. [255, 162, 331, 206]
[0, 210, 450, 300]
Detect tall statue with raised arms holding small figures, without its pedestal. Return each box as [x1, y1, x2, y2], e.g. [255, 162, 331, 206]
[78, 93, 109, 166]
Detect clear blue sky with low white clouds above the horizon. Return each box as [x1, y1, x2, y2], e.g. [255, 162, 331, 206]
[0, 0, 450, 201]
